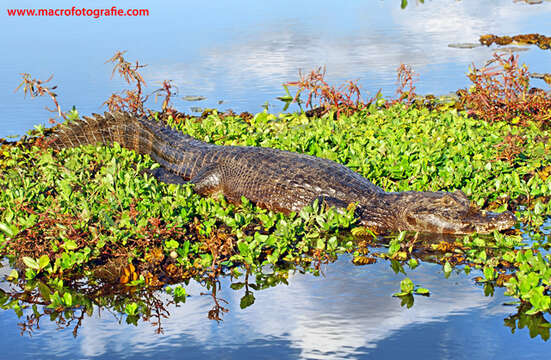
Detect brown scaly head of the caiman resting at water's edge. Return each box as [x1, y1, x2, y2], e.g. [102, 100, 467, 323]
[382, 191, 517, 234]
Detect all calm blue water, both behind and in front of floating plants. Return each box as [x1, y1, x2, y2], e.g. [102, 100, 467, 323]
[0, 0, 551, 359]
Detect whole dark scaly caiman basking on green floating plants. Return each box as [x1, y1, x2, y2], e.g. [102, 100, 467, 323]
[49, 112, 516, 234]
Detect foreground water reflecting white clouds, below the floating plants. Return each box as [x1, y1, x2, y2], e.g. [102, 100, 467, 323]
[0, 256, 549, 359]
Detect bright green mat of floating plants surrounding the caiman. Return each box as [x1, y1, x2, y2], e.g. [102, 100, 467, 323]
[0, 105, 551, 322]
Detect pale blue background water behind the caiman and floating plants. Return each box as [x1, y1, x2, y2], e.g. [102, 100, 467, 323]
[0, 0, 551, 137]
